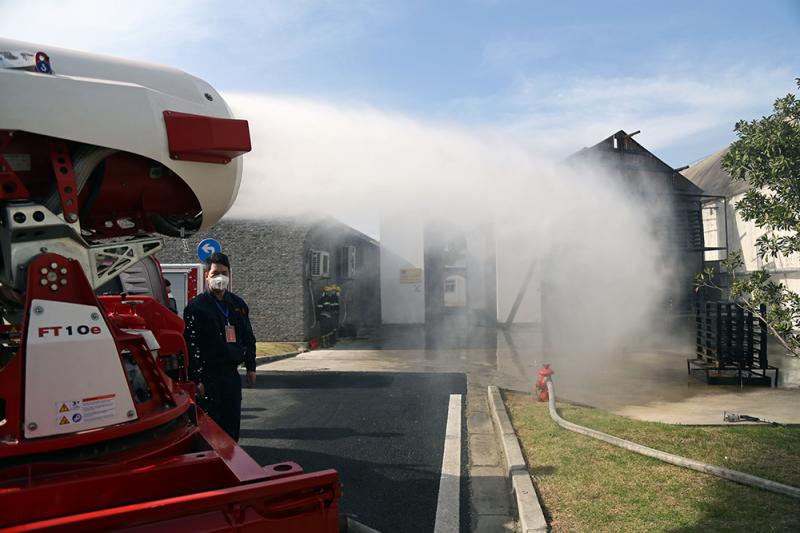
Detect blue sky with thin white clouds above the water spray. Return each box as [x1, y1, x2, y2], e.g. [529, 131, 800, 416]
[0, 0, 800, 235]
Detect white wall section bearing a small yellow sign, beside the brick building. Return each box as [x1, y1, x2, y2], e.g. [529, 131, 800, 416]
[380, 216, 425, 324]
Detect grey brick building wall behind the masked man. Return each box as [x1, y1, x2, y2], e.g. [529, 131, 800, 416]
[158, 218, 381, 341]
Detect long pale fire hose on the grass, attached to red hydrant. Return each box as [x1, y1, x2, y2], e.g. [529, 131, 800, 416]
[547, 378, 800, 498]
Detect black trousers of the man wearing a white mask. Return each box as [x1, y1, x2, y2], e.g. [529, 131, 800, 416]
[200, 366, 242, 442]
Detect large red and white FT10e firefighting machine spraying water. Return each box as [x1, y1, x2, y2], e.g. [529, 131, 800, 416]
[0, 39, 341, 532]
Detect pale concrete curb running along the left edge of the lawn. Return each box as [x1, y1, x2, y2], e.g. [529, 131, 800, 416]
[488, 385, 549, 533]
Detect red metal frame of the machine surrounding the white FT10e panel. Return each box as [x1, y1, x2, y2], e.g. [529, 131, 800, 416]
[0, 254, 341, 533]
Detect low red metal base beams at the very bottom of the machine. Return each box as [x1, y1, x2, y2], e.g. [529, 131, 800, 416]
[0, 411, 341, 532]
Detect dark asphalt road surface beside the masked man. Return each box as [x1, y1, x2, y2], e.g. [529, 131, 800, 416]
[240, 372, 469, 533]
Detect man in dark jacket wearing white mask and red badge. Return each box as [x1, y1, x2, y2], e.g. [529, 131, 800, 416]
[183, 253, 256, 441]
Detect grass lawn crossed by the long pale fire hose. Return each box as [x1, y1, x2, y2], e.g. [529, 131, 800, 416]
[506, 393, 800, 533]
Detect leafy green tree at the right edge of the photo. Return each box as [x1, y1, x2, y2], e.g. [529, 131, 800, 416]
[695, 78, 800, 356]
